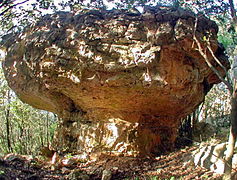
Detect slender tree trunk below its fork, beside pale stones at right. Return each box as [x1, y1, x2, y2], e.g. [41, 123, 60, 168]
[224, 90, 237, 179]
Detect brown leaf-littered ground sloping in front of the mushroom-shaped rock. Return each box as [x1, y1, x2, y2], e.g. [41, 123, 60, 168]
[0, 145, 230, 180]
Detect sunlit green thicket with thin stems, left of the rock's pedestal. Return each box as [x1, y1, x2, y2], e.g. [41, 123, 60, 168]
[0, 63, 57, 155]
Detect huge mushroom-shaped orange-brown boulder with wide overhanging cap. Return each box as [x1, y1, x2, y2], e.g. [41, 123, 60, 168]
[0, 7, 228, 154]
